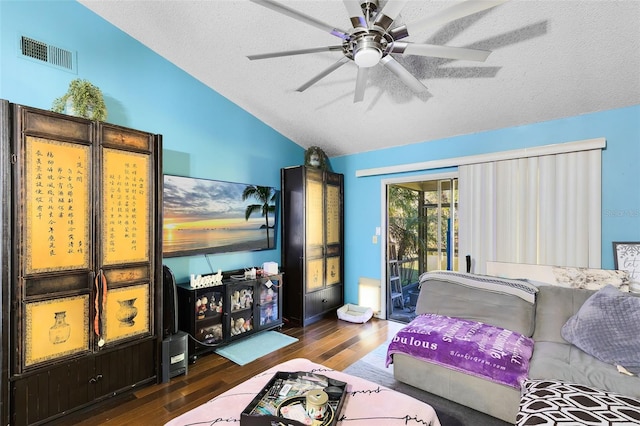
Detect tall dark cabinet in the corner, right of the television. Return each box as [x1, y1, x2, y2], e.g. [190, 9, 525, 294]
[281, 166, 344, 326]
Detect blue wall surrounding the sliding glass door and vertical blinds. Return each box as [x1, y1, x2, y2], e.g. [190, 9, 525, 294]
[331, 105, 640, 302]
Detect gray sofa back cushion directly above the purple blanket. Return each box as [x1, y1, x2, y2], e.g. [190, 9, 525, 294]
[416, 271, 538, 337]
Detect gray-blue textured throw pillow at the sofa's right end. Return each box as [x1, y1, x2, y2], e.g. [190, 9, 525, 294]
[562, 286, 640, 374]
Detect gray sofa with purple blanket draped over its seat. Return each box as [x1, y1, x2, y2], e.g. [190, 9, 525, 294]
[393, 273, 640, 424]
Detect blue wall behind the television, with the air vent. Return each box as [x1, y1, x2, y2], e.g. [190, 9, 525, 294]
[0, 0, 304, 280]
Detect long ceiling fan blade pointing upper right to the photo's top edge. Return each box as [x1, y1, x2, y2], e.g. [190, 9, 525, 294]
[390, 0, 509, 40]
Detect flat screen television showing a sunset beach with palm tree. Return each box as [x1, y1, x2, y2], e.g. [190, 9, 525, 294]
[162, 175, 280, 257]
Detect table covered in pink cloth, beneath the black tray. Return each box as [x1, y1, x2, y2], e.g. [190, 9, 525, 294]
[166, 358, 440, 426]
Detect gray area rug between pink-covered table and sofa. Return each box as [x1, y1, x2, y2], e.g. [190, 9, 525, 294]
[343, 343, 509, 426]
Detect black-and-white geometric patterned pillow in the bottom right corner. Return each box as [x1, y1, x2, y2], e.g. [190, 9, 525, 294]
[516, 380, 640, 426]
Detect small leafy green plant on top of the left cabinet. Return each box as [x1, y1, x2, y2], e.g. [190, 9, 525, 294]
[51, 78, 107, 121]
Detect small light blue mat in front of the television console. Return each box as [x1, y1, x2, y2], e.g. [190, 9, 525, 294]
[216, 331, 298, 365]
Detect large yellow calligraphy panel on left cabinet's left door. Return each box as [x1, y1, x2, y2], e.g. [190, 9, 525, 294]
[24, 136, 92, 274]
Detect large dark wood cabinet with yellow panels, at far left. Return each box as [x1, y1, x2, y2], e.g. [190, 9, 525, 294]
[0, 101, 162, 425]
